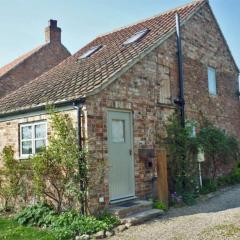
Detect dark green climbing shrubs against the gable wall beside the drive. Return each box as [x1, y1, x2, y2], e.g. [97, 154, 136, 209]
[165, 114, 239, 194]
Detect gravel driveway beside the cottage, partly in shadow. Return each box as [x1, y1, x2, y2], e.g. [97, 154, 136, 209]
[111, 185, 240, 240]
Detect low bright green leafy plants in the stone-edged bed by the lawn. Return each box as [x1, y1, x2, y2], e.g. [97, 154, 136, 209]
[15, 204, 120, 240]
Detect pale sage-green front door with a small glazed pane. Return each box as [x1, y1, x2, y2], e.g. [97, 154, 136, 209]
[107, 111, 135, 201]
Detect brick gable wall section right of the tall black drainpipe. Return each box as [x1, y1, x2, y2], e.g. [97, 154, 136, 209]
[183, 6, 240, 139]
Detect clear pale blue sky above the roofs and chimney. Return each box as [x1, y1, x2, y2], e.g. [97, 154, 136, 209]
[0, 0, 240, 69]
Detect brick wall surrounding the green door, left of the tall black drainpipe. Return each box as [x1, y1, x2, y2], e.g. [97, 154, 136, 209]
[86, 46, 176, 209]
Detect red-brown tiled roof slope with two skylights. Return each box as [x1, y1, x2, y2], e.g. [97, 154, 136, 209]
[0, 0, 207, 113]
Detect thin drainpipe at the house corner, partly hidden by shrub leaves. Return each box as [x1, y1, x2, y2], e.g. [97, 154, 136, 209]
[73, 99, 86, 215]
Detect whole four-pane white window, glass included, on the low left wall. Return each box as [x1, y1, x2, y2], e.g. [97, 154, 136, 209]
[20, 122, 47, 158]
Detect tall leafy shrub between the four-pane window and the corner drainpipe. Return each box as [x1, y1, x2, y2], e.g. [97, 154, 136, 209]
[31, 110, 88, 212]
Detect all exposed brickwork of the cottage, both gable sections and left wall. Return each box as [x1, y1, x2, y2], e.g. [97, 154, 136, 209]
[0, 5, 240, 210]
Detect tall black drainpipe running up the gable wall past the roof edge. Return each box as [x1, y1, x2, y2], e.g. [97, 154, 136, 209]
[174, 13, 185, 128]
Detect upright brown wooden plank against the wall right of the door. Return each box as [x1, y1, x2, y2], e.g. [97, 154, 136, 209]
[157, 149, 168, 207]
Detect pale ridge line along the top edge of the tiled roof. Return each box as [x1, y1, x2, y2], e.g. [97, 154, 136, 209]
[95, 0, 206, 39]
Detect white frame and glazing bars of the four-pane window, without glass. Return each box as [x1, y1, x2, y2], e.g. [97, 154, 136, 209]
[19, 121, 48, 159]
